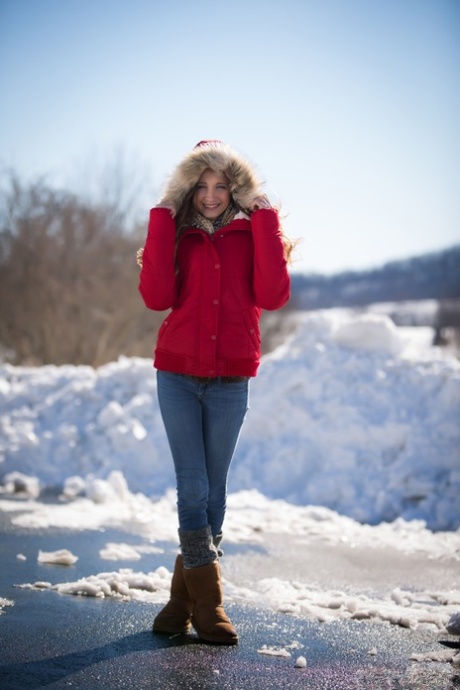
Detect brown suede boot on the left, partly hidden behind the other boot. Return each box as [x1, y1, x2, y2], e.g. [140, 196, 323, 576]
[153, 556, 192, 635]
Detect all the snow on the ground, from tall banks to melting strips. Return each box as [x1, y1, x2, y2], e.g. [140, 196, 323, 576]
[0, 310, 460, 660]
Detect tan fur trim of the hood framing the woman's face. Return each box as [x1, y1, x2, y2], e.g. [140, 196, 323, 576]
[160, 141, 263, 213]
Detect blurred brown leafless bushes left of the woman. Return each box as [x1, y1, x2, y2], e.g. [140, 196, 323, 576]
[0, 174, 162, 366]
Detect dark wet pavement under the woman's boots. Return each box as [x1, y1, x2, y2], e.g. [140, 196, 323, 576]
[0, 523, 460, 690]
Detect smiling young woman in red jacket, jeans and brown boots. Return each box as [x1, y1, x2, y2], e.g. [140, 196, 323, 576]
[138, 140, 292, 644]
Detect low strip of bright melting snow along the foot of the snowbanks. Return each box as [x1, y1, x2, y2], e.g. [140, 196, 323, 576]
[0, 472, 460, 561]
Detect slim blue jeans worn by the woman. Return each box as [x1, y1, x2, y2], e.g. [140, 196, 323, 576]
[157, 371, 249, 537]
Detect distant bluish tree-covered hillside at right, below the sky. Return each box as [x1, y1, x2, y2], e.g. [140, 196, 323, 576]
[290, 245, 460, 309]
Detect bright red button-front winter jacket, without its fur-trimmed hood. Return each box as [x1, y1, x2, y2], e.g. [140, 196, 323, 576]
[139, 208, 290, 377]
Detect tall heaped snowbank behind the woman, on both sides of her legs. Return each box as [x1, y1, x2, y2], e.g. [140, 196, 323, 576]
[0, 310, 460, 530]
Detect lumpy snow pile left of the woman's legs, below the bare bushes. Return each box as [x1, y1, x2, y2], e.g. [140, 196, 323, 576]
[0, 358, 169, 493]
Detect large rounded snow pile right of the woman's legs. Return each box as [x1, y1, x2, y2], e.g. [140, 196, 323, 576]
[234, 313, 460, 529]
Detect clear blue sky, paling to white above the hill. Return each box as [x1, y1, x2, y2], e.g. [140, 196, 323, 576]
[0, 0, 460, 272]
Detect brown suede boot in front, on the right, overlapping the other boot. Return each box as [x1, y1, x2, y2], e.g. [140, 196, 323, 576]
[184, 561, 238, 644]
